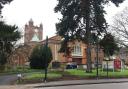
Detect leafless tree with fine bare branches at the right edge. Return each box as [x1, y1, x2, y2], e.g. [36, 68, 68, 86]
[110, 7, 128, 47]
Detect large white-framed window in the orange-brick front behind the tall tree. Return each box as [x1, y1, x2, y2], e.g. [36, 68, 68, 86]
[72, 44, 82, 56]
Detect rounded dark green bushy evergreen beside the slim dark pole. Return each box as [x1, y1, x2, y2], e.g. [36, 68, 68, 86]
[30, 45, 52, 69]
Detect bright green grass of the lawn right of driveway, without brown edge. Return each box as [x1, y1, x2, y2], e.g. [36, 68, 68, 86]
[24, 69, 128, 79]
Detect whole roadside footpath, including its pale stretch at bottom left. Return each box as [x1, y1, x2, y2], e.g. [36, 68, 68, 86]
[0, 79, 128, 89]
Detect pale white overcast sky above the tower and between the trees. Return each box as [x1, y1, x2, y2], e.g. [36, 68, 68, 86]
[2, 0, 128, 38]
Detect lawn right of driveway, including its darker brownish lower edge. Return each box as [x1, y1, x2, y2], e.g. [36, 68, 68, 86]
[17, 69, 128, 83]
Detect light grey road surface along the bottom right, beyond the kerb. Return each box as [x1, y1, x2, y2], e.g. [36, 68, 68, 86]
[34, 83, 128, 89]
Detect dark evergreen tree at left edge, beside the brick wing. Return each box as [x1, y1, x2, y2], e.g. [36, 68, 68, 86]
[0, 22, 21, 65]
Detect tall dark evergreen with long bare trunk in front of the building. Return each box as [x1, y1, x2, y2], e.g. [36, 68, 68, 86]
[55, 0, 124, 72]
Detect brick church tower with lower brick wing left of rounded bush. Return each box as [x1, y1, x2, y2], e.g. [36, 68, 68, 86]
[9, 19, 43, 66]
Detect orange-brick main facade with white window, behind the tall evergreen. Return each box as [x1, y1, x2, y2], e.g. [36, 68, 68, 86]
[42, 36, 104, 64]
